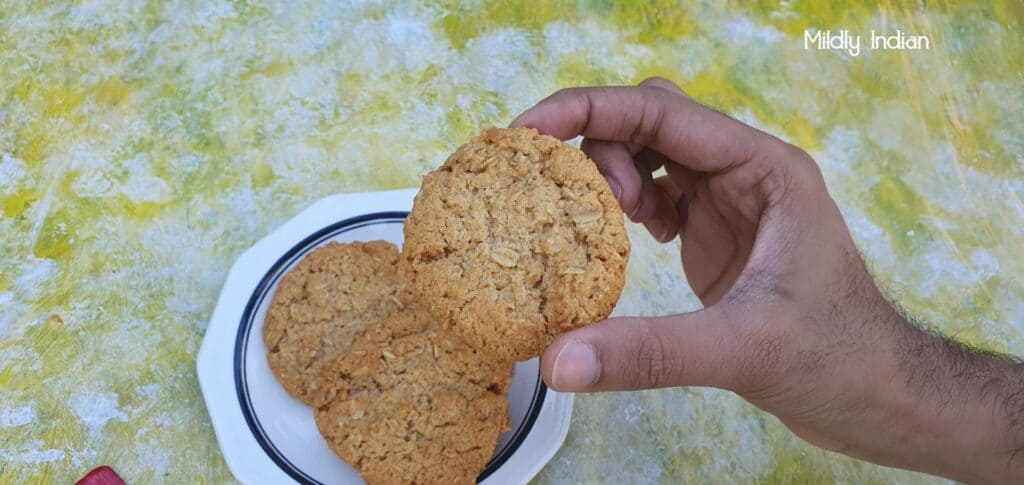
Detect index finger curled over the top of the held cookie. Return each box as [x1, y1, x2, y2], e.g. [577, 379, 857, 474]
[511, 86, 781, 172]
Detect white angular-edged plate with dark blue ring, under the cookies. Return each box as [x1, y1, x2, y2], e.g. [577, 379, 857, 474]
[197, 189, 572, 484]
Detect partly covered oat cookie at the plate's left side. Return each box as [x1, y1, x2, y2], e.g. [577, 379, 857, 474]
[263, 240, 412, 405]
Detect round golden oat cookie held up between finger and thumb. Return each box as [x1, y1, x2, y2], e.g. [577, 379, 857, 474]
[402, 128, 630, 360]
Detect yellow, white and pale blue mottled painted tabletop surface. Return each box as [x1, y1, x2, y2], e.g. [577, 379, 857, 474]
[0, 0, 1024, 483]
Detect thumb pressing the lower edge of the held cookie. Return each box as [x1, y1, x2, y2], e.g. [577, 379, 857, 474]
[541, 306, 743, 392]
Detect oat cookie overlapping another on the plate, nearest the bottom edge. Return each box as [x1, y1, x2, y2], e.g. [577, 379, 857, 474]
[315, 309, 512, 484]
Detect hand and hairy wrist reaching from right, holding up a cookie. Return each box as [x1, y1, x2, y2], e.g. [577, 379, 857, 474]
[512, 79, 1024, 481]
